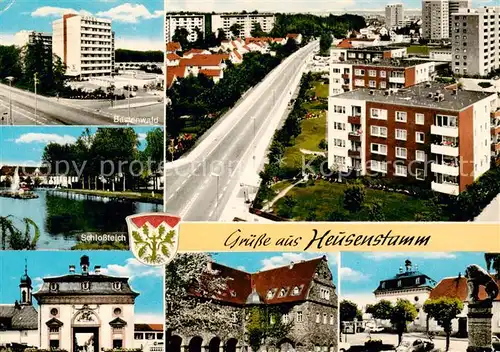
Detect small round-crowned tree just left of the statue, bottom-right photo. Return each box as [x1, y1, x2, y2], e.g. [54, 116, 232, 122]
[424, 297, 464, 351]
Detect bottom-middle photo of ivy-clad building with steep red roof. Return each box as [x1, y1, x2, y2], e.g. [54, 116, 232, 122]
[165, 252, 338, 352]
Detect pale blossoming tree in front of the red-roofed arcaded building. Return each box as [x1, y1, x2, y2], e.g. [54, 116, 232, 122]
[165, 253, 236, 349]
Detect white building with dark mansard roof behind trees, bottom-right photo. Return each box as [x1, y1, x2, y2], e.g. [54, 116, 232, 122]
[373, 259, 436, 331]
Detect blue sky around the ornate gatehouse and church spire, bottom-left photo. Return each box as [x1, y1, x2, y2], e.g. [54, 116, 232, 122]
[0, 251, 164, 324]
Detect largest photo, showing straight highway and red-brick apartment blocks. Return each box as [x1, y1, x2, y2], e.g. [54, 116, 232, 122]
[165, 0, 500, 223]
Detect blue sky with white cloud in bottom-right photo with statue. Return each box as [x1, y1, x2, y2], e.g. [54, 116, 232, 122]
[340, 252, 486, 306]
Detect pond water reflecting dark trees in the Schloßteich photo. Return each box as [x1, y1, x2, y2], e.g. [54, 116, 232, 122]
[0, 190, 163, 249]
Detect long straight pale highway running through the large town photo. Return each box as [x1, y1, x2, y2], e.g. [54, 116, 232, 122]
[165, 42, 317, 221]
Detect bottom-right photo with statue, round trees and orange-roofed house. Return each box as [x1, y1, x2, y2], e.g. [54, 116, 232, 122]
[339, 252, 500, 352]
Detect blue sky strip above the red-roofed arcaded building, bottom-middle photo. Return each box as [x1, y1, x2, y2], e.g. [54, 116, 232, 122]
[207, 252, 338, 286]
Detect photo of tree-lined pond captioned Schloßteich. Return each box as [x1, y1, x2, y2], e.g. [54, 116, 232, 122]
[0, 126, 164, 250]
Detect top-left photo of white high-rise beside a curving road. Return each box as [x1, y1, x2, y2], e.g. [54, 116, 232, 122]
[0, 0, 165, 125]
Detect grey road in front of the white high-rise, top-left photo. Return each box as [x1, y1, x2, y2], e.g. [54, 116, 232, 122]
[0, 84, 163, 125]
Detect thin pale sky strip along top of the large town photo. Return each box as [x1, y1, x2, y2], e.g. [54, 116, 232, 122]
[166, 0, 500, 13]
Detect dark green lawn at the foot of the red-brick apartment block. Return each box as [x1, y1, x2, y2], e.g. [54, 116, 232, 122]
[273, 180, 430, 221]
